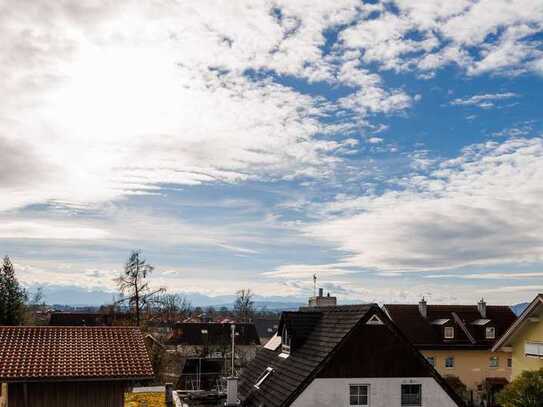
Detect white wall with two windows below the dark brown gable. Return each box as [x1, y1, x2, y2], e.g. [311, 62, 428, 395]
[291, 377, 457, 407]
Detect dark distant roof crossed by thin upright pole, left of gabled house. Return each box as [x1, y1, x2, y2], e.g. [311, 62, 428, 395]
[165, 322, 260, 346]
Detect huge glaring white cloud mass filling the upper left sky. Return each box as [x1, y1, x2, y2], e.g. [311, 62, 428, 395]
[0, 0, 409, 214]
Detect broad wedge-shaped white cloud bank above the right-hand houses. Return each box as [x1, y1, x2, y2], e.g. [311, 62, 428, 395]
[284, 138, 543, 273]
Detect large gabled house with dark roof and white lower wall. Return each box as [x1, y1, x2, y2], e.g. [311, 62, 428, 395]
[239, 304, 463, 407]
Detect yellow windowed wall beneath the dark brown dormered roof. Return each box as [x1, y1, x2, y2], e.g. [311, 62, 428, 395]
[422, 350, 514, 391]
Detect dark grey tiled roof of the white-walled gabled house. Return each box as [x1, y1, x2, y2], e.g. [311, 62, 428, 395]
[240, 304, 463, 407]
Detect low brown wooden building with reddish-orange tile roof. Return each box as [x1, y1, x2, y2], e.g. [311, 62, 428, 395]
[0, 326, 153, 407]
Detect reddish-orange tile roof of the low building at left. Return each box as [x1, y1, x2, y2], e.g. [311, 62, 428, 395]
[0, 326, 153, 382]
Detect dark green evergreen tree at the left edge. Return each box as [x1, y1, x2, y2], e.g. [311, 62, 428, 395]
[0, 256, 26, 325]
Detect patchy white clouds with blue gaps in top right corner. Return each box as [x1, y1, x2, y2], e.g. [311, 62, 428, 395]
[341, 0, 543, 77]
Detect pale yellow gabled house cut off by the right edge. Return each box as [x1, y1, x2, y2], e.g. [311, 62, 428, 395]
[492, 294, 543, 379]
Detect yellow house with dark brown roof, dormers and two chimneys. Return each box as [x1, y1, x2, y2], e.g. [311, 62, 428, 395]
[384, 299, 516, 401]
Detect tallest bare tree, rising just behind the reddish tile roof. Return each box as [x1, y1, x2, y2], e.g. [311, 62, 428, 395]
[116, 250, 164, 326]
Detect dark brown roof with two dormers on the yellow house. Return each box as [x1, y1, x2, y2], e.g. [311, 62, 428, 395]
[384, 299, 517, 350]
